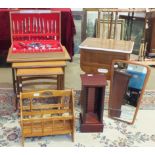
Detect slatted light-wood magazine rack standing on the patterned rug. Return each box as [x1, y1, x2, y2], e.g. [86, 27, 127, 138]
[20, 90, 75, 145]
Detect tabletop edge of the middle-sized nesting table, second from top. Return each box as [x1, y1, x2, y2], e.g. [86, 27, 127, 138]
[12, 61, 66, 68]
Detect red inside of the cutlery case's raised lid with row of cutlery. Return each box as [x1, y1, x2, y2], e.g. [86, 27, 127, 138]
[12, 16, 59, 40]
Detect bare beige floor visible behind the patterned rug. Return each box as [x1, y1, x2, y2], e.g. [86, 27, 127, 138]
[0, 54, 155, 90]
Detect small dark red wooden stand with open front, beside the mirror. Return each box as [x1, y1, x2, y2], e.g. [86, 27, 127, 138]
[80, 74, 107, 132]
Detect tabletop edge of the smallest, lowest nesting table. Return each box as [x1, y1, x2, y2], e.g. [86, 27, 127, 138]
[17, 68, 63, 76]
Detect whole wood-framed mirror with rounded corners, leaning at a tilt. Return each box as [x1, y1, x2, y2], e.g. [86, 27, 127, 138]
[108, 60, 150, 124]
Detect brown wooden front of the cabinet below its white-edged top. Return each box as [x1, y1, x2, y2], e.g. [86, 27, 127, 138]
[80, 49, 130, 80]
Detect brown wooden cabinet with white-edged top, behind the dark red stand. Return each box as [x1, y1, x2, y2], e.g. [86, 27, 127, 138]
[79, 38, 134, 80]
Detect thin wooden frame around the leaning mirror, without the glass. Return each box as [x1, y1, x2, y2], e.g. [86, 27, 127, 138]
[108, 59, 151, 124]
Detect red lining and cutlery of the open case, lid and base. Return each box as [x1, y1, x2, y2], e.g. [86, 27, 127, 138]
[10, 12, 63, 53]
